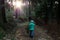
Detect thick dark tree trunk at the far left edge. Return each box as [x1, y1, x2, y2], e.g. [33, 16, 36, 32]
[0, 0, 7, 23]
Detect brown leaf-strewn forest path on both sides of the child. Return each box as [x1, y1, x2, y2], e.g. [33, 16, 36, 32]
[0, 22, 53, 40]
